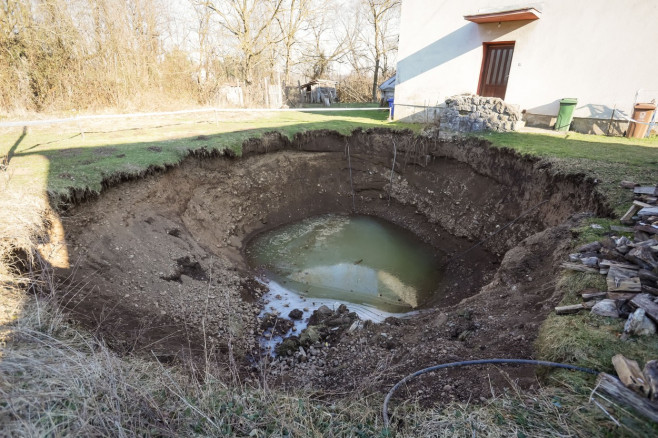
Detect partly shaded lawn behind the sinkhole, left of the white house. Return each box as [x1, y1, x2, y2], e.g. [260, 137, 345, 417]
[0, 110, 418, 198]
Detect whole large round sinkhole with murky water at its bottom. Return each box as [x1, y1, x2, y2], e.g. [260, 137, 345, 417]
[57, 130, 609, 393]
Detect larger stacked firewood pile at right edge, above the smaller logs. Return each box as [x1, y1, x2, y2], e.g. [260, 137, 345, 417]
[555, 181, 658, 336]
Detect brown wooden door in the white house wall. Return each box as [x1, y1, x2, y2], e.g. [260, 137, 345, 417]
[478, 43, 514, 99]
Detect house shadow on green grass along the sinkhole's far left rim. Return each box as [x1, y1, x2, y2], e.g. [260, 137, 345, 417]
[11, 116, 400, 199]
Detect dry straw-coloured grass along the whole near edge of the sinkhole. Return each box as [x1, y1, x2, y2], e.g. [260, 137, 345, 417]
[0, 271, 655, 437]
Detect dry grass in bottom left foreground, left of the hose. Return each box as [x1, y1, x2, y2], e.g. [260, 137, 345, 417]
[0, 290, 380, 437]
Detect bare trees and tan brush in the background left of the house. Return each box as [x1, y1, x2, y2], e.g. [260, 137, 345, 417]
[0, 0, 400, 111]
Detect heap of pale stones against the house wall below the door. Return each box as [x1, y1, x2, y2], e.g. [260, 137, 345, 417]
[440, 94, 523, 132]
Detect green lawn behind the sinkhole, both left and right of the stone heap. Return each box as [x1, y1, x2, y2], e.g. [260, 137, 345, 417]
[0, 104, 658, 209]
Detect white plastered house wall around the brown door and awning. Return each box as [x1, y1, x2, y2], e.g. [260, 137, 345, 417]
[395, 0, 658, 126]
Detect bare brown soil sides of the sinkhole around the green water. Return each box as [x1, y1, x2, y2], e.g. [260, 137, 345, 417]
[59, 130, 610, 402]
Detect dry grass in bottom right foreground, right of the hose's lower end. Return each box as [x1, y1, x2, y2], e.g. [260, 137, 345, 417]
[399, 376, 656, 438]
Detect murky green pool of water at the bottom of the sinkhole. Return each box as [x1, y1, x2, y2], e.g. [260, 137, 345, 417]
[245, 214, 440, 321]
